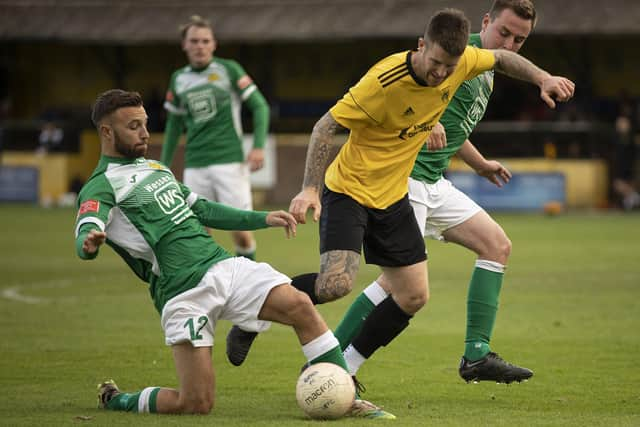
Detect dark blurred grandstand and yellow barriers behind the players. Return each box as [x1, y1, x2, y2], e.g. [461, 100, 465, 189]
[0, 0, 640, 211]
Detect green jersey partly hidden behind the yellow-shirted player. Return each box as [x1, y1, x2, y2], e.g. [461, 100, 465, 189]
[411, 34, 494, 184]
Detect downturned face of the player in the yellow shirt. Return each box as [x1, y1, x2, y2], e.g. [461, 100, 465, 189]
[412, 38, 460, 86]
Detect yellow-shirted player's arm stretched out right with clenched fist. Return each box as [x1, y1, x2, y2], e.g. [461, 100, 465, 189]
[492, 49, 575, 108]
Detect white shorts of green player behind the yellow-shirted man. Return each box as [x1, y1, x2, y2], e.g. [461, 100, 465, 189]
[409, 178, 482, 244]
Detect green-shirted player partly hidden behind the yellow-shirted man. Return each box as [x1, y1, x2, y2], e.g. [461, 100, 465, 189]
[336, 0, 544, 383]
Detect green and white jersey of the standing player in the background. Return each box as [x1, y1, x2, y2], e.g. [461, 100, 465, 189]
[162, 57, 257, 167]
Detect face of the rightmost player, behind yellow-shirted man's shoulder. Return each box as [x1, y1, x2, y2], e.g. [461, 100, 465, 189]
[480, 9, 532, 52]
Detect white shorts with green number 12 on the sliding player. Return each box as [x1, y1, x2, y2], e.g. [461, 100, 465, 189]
[160, 257, 291, 347]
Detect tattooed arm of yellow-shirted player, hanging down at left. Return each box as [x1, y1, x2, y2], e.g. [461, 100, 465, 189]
[289, 112, 342, 224]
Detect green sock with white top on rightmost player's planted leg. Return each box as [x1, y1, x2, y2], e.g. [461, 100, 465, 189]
[464, 260, 504, 361]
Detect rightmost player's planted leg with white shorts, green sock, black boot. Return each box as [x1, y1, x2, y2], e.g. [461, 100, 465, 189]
[438, 188, 533, 382]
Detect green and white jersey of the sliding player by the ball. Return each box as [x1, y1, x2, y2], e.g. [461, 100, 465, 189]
[75, 156, 267, 312]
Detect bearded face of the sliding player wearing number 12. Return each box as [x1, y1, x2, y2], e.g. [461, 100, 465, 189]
[109, 106, 149, 158]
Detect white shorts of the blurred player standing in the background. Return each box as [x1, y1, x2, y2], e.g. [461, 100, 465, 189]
[183, 163, 253, 210]
